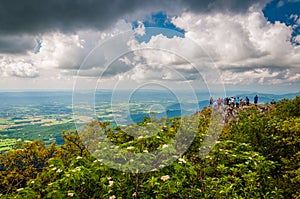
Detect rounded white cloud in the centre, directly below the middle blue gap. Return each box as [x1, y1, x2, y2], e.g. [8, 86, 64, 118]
[122, 34, 202, 81]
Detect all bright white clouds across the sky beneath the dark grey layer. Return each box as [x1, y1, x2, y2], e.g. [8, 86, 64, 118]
[0, 7, 300, 91]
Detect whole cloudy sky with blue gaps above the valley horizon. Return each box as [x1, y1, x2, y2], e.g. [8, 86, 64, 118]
[0, 0, 300, 93]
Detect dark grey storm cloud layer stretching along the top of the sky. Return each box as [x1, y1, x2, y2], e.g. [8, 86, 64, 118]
[0, 0, 265, 35]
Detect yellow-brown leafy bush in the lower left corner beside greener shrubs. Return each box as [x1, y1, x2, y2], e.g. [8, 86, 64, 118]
[0, 132, 88, 194]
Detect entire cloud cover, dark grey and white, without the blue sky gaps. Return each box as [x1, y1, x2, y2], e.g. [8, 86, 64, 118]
[0, 0, 300, 91]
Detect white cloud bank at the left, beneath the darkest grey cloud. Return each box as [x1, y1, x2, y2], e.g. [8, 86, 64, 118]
[0, 20, 131, 77]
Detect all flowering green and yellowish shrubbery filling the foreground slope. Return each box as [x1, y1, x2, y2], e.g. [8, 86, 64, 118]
[0, 97, 300, 199]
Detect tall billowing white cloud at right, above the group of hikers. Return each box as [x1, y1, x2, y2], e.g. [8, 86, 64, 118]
[173, 8, 300, 84]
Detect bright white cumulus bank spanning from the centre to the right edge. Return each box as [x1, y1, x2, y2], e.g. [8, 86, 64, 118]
[89, 7, 300, 84]
